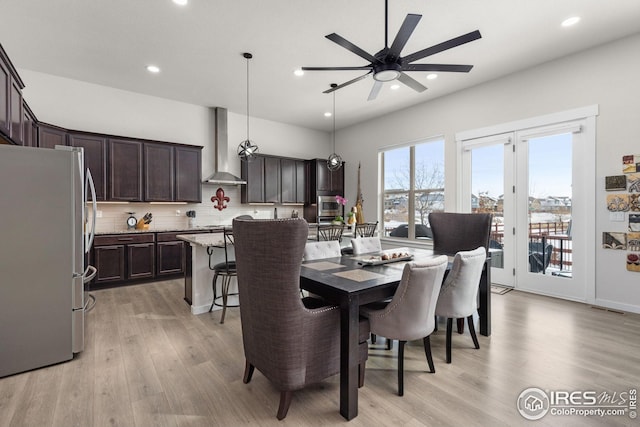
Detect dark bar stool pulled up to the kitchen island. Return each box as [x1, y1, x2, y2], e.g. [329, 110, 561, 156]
[207, 215, 252, 323]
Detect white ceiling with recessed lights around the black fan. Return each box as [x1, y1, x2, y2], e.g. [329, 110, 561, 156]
[0, 0, 640, 131]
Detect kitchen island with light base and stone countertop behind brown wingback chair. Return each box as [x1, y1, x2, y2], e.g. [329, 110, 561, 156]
[176, 231, 230, 314]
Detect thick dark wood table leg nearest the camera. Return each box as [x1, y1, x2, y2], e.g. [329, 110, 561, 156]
[340, 296, 360, 420]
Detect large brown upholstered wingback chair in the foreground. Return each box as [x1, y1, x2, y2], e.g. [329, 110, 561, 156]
[233, 218, 369, 420]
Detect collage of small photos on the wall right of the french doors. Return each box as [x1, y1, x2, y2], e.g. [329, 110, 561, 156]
[602, 155, 640, 272]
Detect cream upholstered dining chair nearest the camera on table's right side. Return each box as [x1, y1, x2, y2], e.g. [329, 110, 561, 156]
[360, 255, 448, 396]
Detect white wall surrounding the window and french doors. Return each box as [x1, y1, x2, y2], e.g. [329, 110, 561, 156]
[336, 35, 640, 312]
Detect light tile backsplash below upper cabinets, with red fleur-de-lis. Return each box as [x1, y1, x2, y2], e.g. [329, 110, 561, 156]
[90, 185, 302, 233]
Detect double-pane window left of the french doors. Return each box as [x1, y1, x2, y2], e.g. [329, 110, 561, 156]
[380, 138, 444, 240]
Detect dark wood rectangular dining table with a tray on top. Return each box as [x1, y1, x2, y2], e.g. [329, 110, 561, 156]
[300, 248, 491, 420]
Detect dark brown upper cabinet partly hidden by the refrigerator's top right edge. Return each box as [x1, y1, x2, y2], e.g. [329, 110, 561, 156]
[68, 133, 107, 202]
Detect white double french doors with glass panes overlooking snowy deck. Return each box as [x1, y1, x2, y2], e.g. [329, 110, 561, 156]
[459, 112, 595, 301]
